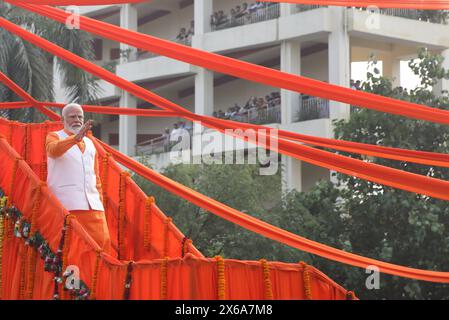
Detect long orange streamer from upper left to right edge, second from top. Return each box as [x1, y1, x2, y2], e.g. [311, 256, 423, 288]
[4, 18, 449, 200]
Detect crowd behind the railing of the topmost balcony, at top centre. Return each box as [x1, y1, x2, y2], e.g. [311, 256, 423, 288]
[211, 1, 279, 29]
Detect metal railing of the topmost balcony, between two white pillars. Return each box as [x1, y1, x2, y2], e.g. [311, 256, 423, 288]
[211, 3, 280, 31]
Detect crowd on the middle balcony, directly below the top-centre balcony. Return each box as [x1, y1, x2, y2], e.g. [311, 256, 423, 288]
[213, 92, 281, 121]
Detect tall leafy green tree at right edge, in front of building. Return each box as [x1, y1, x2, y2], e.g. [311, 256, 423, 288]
[310, 49, 449, 299]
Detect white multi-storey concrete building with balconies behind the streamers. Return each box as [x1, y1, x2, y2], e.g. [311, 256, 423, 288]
[56, 0, 449, 190]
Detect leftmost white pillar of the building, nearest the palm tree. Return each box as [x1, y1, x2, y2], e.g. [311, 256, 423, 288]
[119, 4, 137, 156]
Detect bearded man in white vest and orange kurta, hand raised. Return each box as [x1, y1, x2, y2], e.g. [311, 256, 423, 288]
[46, 103, 111, 252]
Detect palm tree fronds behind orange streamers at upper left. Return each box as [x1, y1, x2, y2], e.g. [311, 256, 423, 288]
[0, 3, 99, 122]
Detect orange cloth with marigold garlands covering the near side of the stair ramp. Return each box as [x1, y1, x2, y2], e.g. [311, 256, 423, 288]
[0, 121, 355, 299]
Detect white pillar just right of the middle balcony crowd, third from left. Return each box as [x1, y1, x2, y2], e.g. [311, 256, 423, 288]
[281, 41, 302, 192]
